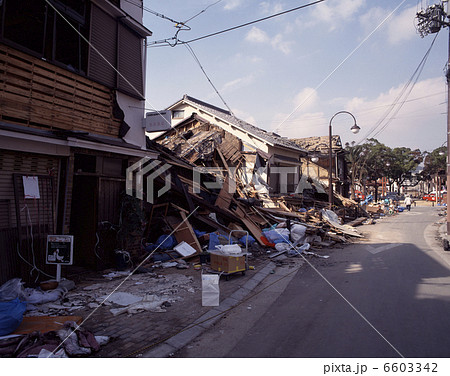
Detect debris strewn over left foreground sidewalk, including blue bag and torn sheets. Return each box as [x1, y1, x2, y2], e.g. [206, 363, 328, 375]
[0, 268, 199, 357]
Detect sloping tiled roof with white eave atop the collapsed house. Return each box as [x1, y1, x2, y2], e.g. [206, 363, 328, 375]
[167, 94, 306, 153]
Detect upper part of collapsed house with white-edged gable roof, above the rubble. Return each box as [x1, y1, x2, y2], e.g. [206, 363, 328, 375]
[155, 95, 307, 195]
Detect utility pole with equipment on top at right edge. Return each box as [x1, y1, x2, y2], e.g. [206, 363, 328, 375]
[416, 0, 450, 250]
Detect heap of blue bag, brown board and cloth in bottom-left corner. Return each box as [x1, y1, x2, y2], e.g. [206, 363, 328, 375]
[0, 278, 109, 358]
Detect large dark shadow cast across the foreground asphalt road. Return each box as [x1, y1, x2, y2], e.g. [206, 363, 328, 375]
[227, 243, 450, 358]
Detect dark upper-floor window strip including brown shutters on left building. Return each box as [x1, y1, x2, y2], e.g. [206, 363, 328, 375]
[0, 0, 146, 99]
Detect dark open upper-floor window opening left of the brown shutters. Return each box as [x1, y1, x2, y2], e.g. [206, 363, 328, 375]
[0, 0, 89, 74]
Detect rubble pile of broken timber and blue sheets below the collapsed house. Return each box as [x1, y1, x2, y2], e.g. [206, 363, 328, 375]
[122, 140, 369, 267]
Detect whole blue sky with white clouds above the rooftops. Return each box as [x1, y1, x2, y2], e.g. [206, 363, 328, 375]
[144, 0, 449, 151]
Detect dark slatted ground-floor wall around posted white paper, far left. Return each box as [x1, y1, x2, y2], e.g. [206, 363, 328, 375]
[0, 150, 59, 283]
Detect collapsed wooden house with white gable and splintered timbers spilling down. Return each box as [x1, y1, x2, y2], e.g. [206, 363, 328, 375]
[136, 96, 366, 264]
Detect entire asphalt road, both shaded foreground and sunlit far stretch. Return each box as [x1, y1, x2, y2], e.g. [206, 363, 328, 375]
[176, 207, 450, 358]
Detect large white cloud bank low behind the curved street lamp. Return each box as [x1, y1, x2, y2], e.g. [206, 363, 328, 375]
[272, 77, 446, 151]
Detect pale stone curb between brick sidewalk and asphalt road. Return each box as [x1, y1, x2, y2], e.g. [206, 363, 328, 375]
[142, 262, 275, 358]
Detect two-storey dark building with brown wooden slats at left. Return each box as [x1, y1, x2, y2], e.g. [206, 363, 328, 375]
[0, 0, 156, 282]
